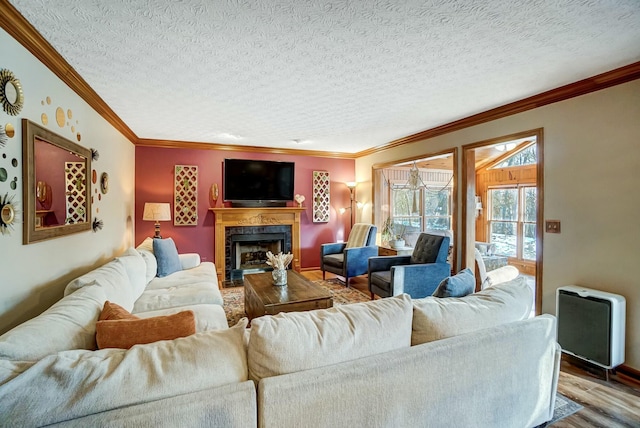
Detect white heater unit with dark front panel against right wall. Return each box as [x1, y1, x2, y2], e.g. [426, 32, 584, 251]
[556, 285, 626, 369]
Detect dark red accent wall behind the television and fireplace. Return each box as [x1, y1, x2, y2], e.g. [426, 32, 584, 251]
[135, 147, 355, 268]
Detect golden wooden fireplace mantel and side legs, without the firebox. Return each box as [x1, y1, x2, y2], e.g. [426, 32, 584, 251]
[209, 207, 306, 287]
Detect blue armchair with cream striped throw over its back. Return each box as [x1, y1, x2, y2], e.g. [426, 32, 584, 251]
[320, 223, 378, 286]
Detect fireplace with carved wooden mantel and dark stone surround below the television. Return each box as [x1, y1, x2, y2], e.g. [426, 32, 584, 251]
[210, 207, 305, 286]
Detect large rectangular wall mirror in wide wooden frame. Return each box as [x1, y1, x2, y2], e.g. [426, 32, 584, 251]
[22, 119, 91, 244]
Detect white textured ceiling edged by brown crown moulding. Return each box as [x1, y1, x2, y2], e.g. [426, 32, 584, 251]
[10, 0, 640, 153]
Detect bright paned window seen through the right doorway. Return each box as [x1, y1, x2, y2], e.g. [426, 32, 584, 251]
[488, 185, 537, 260]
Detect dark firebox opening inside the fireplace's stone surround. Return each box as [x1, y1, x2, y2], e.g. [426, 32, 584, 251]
[230, 233, 285, 280]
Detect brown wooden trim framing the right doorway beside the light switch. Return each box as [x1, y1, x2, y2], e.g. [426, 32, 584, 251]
[460, 128, 544, 315]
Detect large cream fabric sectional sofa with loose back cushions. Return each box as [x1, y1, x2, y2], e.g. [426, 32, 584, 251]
[0, 242, 559, 428]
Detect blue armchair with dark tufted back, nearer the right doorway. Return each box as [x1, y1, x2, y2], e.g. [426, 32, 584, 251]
[368, 233, 451, 299]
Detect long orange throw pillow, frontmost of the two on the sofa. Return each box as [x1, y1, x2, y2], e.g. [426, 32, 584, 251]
[96, 311, 196, 349]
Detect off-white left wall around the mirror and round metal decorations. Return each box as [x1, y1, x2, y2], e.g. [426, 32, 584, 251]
[0, 29, 135, 333]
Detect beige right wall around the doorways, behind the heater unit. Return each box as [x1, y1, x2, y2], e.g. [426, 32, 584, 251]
[356, 80, 640, 370]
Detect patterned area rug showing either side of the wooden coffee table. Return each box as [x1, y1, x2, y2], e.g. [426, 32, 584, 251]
[220, 278, 371, 326]
